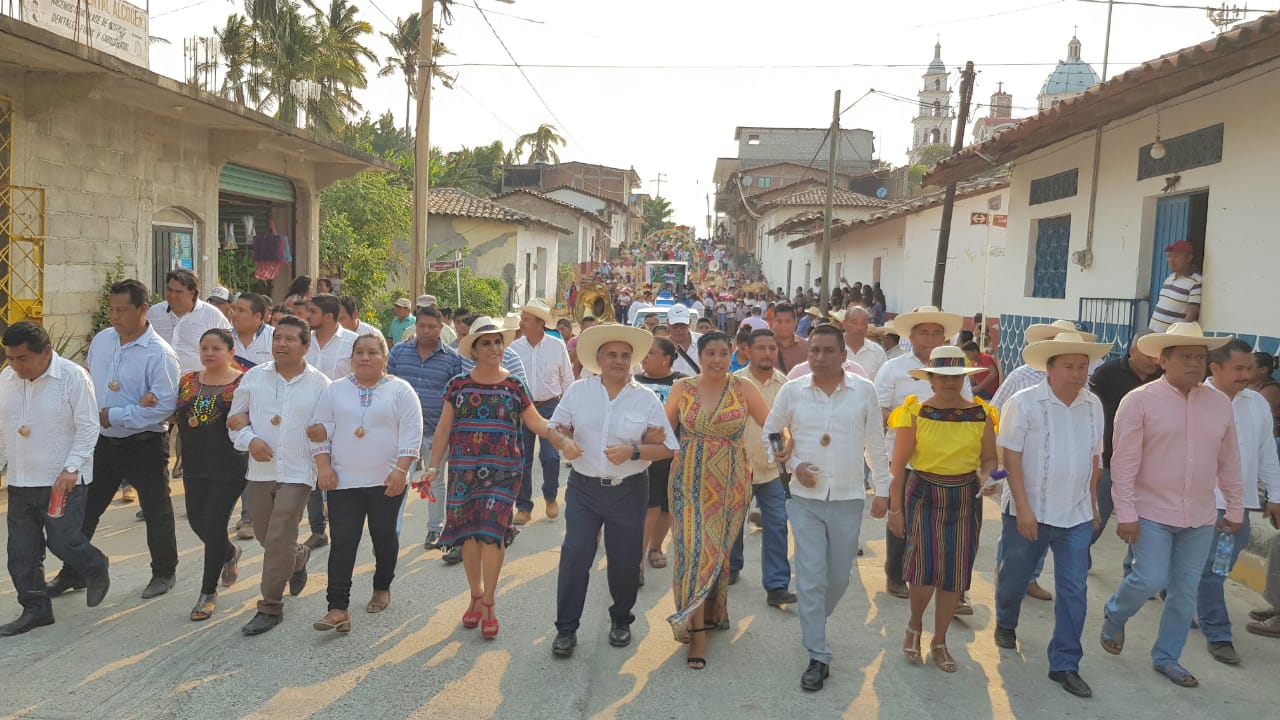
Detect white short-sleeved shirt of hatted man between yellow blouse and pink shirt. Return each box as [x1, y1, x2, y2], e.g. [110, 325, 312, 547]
[996, 380, 1105, 528]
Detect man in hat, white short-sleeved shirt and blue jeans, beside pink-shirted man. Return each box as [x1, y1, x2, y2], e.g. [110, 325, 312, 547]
[996, 332, 1111, 697]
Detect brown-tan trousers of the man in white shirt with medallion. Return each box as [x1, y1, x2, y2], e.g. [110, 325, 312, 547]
[246, 480, 311, 615]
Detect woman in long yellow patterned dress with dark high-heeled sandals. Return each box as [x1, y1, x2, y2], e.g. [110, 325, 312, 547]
[667, 332, 769, 670]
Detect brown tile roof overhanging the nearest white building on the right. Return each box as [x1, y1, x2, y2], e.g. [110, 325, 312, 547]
[924, 13, 1280, 186]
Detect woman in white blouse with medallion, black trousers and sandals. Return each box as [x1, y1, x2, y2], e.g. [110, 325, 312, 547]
[307, 333, 422, 633]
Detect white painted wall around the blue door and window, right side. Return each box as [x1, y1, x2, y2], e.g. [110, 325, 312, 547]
[997, 61, 1280, 336]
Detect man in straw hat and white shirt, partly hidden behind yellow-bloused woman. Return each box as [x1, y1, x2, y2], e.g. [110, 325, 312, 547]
[872, 305, 973, 599]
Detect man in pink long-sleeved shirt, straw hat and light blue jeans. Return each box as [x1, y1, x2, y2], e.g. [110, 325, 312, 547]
[1101, 323, 1244, 687]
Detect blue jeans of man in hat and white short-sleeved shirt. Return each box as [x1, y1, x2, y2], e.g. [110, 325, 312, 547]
[996, 512, 1093, 673]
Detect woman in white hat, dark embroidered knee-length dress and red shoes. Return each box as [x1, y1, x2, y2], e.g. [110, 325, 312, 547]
[422, 315, 580, 638]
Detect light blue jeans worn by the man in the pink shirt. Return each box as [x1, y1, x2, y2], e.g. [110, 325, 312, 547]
[1106, 519, 1213, 667]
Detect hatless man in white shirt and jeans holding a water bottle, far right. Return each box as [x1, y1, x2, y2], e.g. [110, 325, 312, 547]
[1196, 340, 1280, 665]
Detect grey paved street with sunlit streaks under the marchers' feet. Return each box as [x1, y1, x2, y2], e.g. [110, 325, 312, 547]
[0, 480, 1280, 720]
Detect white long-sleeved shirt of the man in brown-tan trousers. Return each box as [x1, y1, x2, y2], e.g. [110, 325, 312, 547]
[227, 360, 329, 487]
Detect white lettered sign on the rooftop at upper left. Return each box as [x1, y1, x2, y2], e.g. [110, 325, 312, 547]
[22, 0, 148, 68]
